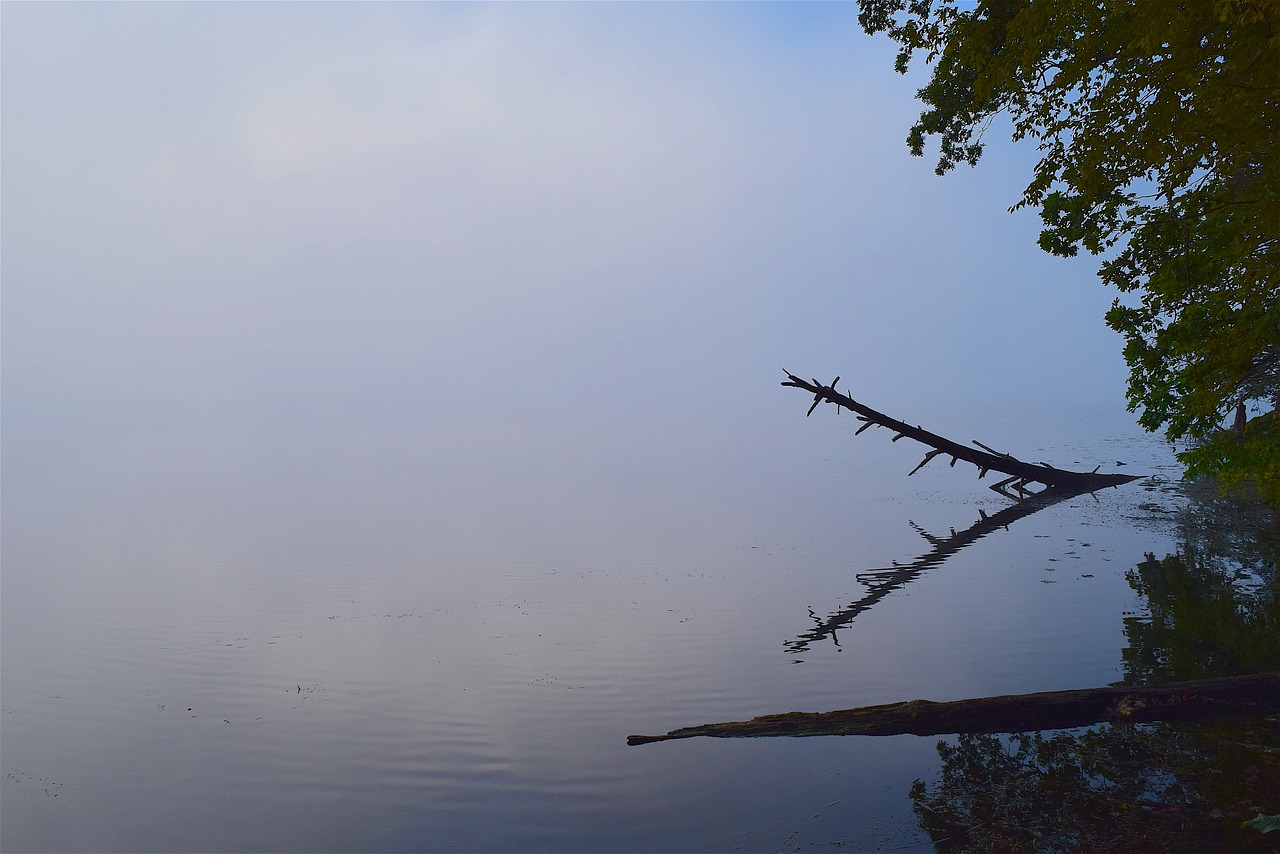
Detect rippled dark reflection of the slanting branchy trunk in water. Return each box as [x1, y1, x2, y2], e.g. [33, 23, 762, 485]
[786, 487, 1089, 653]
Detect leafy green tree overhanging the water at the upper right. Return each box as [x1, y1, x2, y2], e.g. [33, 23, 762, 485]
[859, 0, 1280, 502]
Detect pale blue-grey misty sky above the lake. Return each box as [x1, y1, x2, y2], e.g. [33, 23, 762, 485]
[3, 3, 1124, 448]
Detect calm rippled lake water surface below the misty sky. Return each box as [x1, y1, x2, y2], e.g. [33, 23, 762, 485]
[0, 402, 1180, 851]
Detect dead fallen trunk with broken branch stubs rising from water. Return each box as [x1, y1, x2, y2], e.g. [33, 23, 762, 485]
[782, 371, 1138, 499]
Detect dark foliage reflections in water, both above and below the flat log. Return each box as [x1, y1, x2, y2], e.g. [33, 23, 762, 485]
[911, 495, 1280, 851]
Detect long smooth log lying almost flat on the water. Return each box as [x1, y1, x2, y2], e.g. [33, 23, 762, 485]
[627, 672, 1280, 745]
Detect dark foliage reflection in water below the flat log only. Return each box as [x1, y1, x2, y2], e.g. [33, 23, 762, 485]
[911, 721, 1280, 853]
